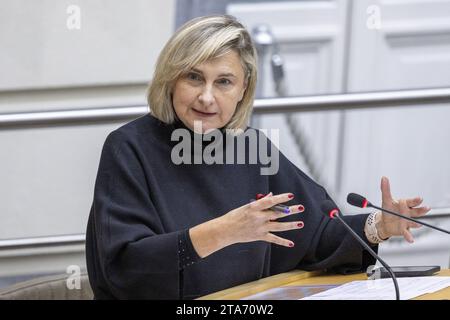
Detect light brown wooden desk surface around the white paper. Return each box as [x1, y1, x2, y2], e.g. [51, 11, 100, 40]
[199, 269, 450, 300]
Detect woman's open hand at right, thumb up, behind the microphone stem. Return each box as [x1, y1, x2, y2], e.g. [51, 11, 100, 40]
[377, 177, 431, 243]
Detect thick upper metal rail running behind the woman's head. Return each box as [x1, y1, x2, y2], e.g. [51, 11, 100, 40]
[0, 88, 450, 129]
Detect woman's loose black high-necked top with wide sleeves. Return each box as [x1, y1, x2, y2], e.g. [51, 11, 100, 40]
[86, 115, 377, 299]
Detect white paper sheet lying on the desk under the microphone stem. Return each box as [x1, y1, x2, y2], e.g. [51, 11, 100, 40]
[301, 277, 450, 300]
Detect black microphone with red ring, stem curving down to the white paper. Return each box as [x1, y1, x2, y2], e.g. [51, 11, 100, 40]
[320, 200, 400, 300]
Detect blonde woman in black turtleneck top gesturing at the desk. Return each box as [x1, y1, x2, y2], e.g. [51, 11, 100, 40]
[86, 16, 429, 299]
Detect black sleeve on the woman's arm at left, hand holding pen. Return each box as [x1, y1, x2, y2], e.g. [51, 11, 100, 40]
[91, 132, 200, 299]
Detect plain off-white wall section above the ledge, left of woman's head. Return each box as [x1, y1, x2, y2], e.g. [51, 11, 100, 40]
[0, 0, 174, 90]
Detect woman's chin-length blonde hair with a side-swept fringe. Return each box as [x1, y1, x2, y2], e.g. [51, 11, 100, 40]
[147, 15, 257, 130]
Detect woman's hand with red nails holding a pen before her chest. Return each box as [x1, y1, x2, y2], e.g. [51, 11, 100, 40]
[220, 192, 304, 247]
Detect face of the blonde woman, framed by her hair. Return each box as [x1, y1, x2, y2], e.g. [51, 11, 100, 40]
[172, 51, 247, 133]
